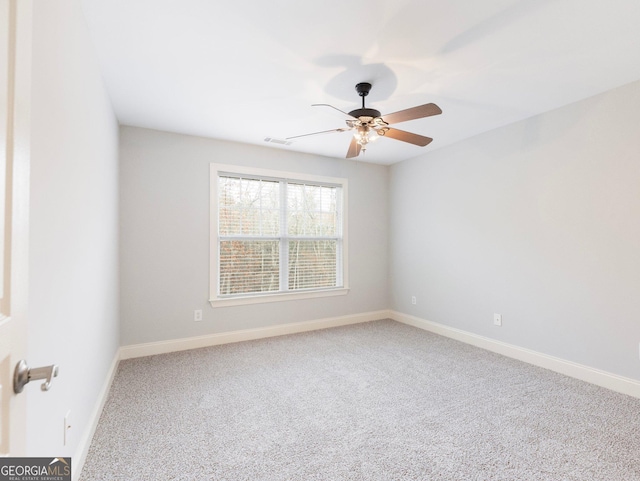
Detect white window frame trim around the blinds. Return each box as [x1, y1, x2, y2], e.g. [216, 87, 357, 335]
[209, 163, 349, 307]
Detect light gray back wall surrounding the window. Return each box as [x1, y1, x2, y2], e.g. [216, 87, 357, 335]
[120, 127, 389, 345]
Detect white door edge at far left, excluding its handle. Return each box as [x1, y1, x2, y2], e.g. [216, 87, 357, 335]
[0, 0, 32, 456]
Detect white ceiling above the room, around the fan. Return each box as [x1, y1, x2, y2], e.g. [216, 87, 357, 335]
[83, 0, 640, 164]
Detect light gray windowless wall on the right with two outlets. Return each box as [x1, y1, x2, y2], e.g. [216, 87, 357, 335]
[390, 82, 640, 379]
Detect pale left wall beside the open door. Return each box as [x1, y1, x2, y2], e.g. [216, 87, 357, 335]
[25, 0, 119, 456]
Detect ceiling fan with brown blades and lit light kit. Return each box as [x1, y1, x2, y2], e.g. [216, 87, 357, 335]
[287, 82, 442, 159]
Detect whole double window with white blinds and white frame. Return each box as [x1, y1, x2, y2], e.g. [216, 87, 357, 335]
[211, 164, 347, 306]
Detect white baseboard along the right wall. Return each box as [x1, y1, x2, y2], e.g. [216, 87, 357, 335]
[389, 311, 640, 398]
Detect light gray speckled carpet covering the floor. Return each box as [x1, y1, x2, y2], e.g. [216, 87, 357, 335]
[80, 320, 640, 481]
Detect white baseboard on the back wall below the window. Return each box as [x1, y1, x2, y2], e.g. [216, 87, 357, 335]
[120, 310, 391, 359]
